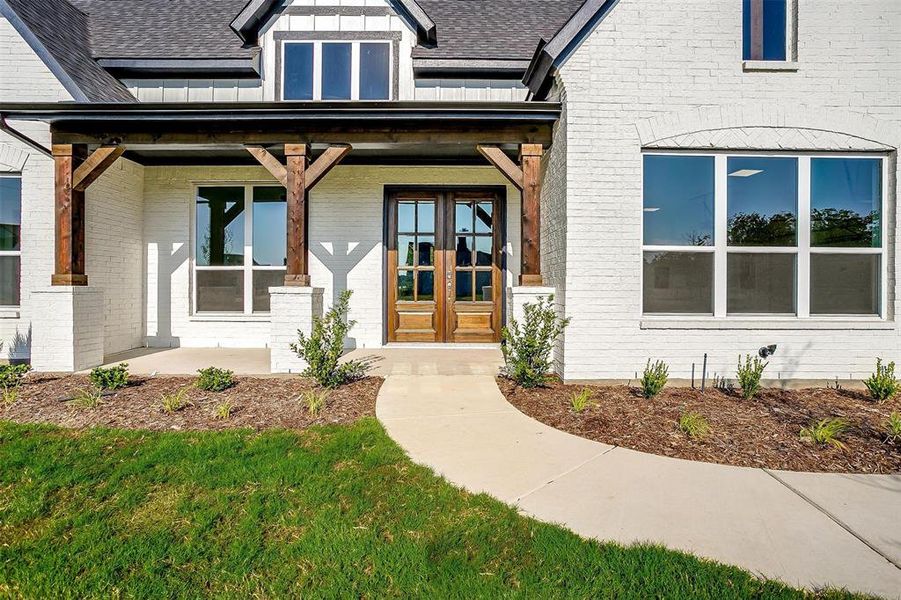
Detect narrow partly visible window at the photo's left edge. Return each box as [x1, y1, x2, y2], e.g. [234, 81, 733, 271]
[0, 175, 22, 306]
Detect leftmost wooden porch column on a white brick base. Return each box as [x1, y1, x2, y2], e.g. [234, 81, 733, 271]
[50, 144, 88, 286]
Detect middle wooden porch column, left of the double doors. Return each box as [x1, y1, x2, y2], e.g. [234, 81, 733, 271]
[285, 144, 310, 286]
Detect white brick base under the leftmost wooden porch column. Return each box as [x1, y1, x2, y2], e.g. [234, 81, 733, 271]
[31, 286, 103, 373]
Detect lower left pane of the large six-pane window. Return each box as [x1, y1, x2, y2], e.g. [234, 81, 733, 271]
[642, 252, 713, 314]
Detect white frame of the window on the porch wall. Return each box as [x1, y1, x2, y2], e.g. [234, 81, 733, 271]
[190, 181, 288, 317]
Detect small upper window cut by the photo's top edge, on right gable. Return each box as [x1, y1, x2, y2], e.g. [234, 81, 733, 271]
[742, 0, 790, 61]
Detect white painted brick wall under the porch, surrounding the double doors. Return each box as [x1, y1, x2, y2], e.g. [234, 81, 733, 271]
[144, 165, 520, 348]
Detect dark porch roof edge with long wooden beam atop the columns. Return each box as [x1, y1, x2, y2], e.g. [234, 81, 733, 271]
[0, 102, 560, 164]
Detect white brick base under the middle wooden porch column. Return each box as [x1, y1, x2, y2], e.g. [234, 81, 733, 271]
[269, 286, 323, 373]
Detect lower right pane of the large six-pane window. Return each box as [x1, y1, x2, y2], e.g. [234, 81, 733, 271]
[810, 254, 882, 315]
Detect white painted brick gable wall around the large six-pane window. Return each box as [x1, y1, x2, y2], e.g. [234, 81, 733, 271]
[545, 0, 901, 379]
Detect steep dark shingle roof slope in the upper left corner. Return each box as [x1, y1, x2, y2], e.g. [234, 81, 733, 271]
[0, 0, 134, 102]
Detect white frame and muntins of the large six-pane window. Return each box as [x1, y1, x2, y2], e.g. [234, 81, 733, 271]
[639, 150, 894, 321]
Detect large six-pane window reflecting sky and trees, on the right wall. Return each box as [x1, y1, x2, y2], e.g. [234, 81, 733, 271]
[642, 153, 886, 318]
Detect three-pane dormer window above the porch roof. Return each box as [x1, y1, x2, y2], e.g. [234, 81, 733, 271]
[282, 41, 391, 100]
